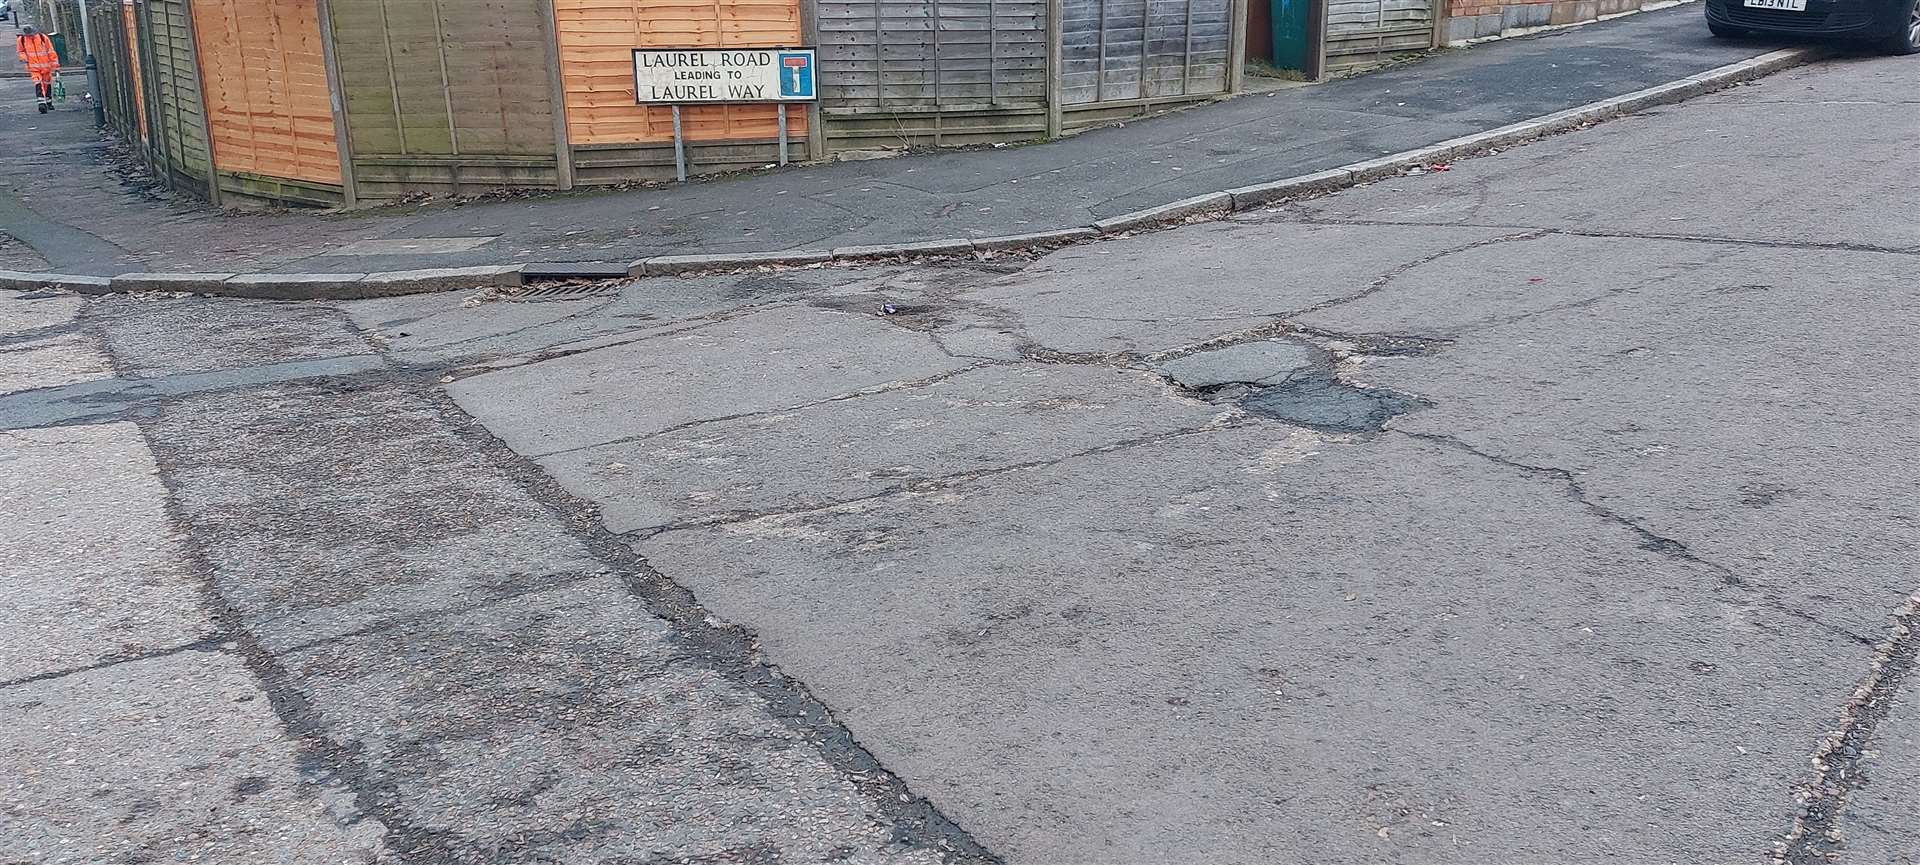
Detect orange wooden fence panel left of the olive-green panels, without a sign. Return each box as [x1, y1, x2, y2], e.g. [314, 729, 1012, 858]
[192, 0, 340, 184]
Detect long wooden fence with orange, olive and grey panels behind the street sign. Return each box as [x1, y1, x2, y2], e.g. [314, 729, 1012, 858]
[78, 0, 1274, 205]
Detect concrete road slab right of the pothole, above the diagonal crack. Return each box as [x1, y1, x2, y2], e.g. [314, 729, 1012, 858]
[1306, 238, 1920, 639]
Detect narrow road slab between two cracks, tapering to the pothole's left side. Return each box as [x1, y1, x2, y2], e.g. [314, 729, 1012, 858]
[541, 364, 1227, 531]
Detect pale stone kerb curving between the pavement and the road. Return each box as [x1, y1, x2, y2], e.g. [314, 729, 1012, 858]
[0, 48, 1826, 299]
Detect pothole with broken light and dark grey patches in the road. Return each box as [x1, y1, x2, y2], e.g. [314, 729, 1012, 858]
[1154, 339, 1427, 433]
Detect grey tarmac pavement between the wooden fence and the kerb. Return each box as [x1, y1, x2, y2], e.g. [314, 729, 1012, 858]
[0, 6, 1776, 276]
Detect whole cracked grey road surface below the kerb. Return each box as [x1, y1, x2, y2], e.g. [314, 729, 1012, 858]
[0, 59, 1920, 865]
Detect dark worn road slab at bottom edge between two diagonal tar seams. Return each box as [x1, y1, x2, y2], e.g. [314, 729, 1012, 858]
[284, 577, 939, 865]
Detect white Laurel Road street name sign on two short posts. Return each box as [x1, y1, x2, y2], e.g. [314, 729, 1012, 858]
[634, 48, 818, 182]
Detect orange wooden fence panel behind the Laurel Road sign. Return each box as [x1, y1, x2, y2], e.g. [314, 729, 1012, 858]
[553, 0, 806, 146]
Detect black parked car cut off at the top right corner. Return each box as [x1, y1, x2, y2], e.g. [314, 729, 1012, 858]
[1707, 0, 1920, 54]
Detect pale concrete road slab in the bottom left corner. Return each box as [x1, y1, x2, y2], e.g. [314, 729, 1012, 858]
[0, 650, 392, 865]
